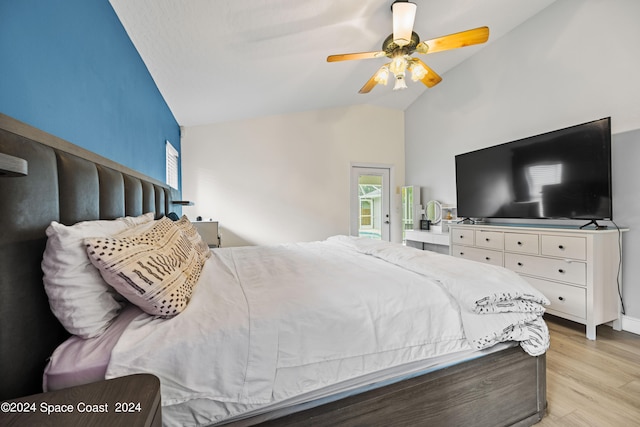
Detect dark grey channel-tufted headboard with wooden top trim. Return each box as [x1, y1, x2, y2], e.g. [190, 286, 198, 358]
[0, 114, 179, 400]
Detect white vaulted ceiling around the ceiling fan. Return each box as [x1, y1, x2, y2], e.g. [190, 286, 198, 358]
[110, 0, 555, 126]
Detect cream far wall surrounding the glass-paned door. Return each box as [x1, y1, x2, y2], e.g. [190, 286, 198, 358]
[181, 105, 405, 246]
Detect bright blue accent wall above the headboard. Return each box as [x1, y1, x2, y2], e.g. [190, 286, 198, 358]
[0, 0, 180, 187]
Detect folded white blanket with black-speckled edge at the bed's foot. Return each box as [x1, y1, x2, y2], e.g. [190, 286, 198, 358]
[329, 236, 550, 356]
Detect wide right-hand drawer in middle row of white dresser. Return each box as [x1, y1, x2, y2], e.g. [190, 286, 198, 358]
[504, 253, 587, 286]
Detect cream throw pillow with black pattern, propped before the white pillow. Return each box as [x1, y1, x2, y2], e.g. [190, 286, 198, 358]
[84, 218, 208, 318]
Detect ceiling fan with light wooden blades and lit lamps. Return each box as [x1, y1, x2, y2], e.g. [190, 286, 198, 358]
[327, 0, 489, 93]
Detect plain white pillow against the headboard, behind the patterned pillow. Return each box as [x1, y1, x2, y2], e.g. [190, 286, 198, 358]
[42, 213, 153, 338]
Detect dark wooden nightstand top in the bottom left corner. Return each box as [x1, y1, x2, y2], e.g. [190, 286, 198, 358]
[0, 374, 162, 427]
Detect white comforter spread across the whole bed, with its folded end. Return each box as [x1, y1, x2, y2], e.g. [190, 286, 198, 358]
[107, 236, 548, 425]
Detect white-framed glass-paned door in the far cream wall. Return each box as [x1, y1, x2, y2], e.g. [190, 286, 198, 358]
[350, 166, 391, 241]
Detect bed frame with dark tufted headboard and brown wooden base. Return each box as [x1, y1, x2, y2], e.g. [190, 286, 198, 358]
[0, 114, 546, 426]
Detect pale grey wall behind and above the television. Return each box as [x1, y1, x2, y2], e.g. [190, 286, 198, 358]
[405, 0, 640, 318]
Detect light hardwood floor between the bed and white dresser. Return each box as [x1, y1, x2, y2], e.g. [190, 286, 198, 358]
[536, 316, 640, 427]
